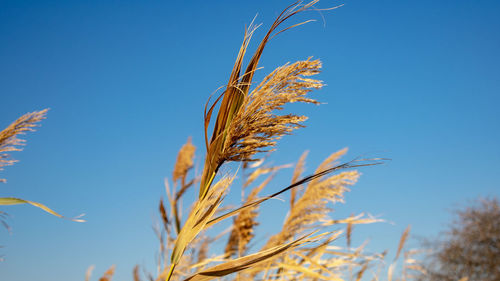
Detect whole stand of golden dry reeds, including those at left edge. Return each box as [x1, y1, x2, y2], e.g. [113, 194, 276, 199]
[0, 0, 430, 281]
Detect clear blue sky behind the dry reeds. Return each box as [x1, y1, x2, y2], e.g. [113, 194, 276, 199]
[0, 0, 500, 281]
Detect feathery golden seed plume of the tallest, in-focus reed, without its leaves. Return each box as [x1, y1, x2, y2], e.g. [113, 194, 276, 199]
[221, 59, 323, 161]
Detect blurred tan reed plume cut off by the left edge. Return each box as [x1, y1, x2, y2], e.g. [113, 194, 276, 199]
[0, 109, 48, 182]
